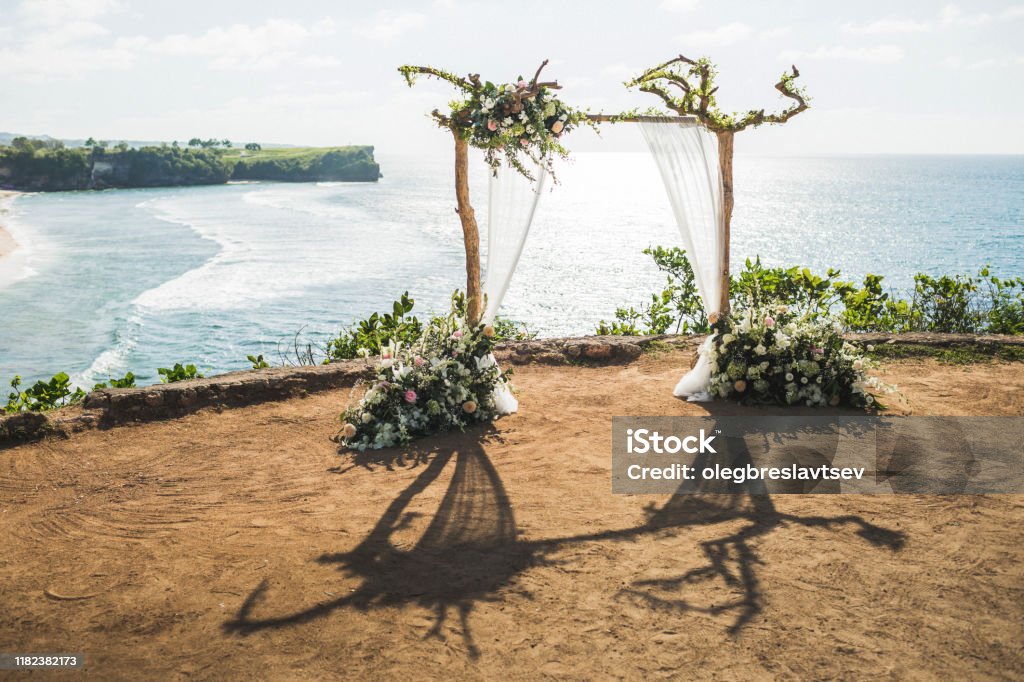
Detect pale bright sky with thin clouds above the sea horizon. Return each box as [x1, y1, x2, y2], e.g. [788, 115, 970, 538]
[0, 0, 1024, 155]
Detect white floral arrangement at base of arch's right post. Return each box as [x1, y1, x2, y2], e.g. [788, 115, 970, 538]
[700, 304, 895, 409]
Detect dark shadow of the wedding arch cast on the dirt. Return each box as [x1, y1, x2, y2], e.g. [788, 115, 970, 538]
[223, 421, 904, 658]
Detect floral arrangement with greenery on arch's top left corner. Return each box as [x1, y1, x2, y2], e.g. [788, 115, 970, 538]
[398, 60, 596, 179]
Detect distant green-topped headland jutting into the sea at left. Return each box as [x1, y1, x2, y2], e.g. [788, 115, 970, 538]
[0, 137, 380, 191]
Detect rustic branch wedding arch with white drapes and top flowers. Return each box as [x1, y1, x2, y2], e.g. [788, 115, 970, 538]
[398, 54, 809, 399]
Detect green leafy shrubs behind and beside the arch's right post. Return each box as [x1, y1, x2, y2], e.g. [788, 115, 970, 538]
[597, 247, 1024, 335]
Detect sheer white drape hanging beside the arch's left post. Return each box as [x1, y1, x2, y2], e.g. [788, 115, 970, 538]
[483, 163, 547, 415]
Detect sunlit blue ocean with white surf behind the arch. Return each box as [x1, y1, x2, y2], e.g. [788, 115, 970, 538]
[0, 154, 1024, 393]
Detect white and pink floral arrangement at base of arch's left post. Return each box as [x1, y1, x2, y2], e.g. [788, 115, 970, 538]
[341, 302, 507, 451]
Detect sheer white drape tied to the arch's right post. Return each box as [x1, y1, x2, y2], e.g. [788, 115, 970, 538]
[640, 119, 725, 400]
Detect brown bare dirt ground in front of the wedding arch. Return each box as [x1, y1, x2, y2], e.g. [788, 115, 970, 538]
[0, 352, 1024, 680]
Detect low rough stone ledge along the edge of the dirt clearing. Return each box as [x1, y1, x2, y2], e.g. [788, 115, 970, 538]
[0, 333, 1024, 449]
